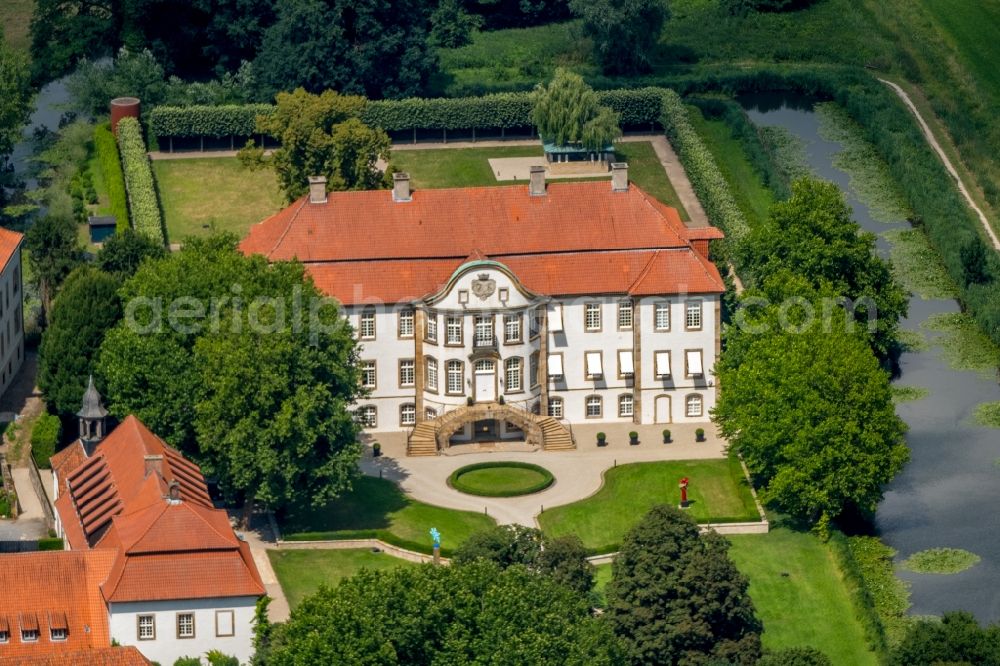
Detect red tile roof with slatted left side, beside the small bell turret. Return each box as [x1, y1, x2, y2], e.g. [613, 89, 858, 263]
[56, 416, 264, 602]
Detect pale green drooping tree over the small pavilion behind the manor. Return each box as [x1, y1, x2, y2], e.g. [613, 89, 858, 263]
[531, 67, 622, 150]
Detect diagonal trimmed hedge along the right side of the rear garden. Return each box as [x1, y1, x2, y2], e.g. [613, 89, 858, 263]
[660, 90, 749, 245]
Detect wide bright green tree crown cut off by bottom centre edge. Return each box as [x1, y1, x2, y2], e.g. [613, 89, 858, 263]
[263, 561, 621, 666]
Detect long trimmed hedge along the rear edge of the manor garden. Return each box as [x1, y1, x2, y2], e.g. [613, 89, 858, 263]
[149, 88, 664, 138]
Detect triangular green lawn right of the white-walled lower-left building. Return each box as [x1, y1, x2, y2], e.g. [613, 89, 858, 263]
[267, 548, 419, 608]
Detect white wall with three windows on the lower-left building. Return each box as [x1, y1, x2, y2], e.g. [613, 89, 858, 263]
[108, 597, 257, 666]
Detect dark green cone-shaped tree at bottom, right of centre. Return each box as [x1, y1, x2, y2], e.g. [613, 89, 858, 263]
[605, 505, 761, 664]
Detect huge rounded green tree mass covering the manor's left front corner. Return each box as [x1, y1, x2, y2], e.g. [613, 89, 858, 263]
[98, 236, 360, 507]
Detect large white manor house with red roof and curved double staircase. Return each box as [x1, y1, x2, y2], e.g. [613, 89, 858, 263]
[241, 163, 724, 455]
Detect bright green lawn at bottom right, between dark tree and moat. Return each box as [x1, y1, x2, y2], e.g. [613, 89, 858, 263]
[729, 528, 877, 666]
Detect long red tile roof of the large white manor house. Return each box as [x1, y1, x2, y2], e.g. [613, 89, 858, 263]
[240, 181, 724, 305]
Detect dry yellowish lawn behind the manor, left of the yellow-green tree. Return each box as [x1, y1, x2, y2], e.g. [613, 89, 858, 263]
[153, 157, 284, 243]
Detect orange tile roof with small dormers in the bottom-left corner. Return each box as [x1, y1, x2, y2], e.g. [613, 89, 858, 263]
[0, 551, 115, 663]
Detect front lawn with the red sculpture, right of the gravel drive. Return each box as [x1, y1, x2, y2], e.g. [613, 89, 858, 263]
[538, 459, 760, 553]
